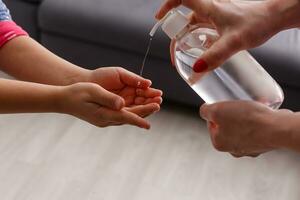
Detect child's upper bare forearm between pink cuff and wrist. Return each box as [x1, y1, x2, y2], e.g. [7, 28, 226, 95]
[0, 37, 87, 85]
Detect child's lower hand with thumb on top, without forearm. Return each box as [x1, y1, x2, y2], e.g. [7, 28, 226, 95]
[59, 82, 160, 129]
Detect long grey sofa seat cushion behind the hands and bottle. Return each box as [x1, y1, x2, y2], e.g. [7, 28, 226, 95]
[39, 0, 300, 88]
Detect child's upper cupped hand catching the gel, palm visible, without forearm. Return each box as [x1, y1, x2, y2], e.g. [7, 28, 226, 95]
[88, 67, 162, 107]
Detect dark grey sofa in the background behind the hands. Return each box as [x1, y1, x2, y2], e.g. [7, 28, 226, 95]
[5, 0, 300, 110]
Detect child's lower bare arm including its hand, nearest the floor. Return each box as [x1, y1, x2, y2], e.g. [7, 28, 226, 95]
[0, 79, 155, 129]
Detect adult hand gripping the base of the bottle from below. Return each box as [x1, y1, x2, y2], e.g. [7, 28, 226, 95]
[200, 101, 293, 157]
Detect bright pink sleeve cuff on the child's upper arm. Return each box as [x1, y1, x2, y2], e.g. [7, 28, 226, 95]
[0, 21, 28, 48]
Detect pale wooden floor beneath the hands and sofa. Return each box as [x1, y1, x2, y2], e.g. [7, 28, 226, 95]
[0, 106, 300, 200]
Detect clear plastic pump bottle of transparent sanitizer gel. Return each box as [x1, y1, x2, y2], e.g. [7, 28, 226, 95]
[150, 9, 284, 109]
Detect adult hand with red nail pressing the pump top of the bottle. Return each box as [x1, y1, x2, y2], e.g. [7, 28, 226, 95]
[156, 0, 300, 72]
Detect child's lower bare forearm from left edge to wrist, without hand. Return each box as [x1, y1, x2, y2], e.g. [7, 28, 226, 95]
[0, 79, 61, 114]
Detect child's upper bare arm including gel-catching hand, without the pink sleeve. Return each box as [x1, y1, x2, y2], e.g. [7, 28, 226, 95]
[0, 36, 162, 106]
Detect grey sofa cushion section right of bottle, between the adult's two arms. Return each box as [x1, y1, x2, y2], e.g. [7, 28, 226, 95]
[251, 29, 300, 88]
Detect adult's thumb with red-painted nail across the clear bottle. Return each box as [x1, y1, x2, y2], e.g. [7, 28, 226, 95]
[193, 35, 242, 73]
